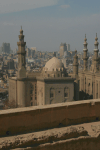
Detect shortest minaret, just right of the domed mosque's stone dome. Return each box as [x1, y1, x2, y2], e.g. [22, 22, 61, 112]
[73, 49, 78, 75]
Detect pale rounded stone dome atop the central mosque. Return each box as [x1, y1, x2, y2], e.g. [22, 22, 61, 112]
[44, 57, 64, 71]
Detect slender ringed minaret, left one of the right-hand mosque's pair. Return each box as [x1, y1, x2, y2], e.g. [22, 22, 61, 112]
[83, 34, 88, 71]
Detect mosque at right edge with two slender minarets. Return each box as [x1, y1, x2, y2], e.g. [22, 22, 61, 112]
[78, 34, 100, 99]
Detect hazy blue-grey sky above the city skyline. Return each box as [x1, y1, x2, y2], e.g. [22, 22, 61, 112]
[0, 0, 100, 51]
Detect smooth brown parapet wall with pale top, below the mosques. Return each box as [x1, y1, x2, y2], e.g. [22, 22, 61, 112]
[0, 99, 100, 136]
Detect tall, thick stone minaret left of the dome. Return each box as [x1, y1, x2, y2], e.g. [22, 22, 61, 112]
[17, 26, 26, 78]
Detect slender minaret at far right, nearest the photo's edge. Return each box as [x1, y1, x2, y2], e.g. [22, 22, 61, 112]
[93, 33, 99, 72]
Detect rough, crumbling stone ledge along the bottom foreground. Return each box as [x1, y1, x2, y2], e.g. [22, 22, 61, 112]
[0, 121, 100, 150]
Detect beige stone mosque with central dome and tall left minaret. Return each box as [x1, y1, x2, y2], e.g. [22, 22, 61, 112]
[9, 28, 79, 107]
